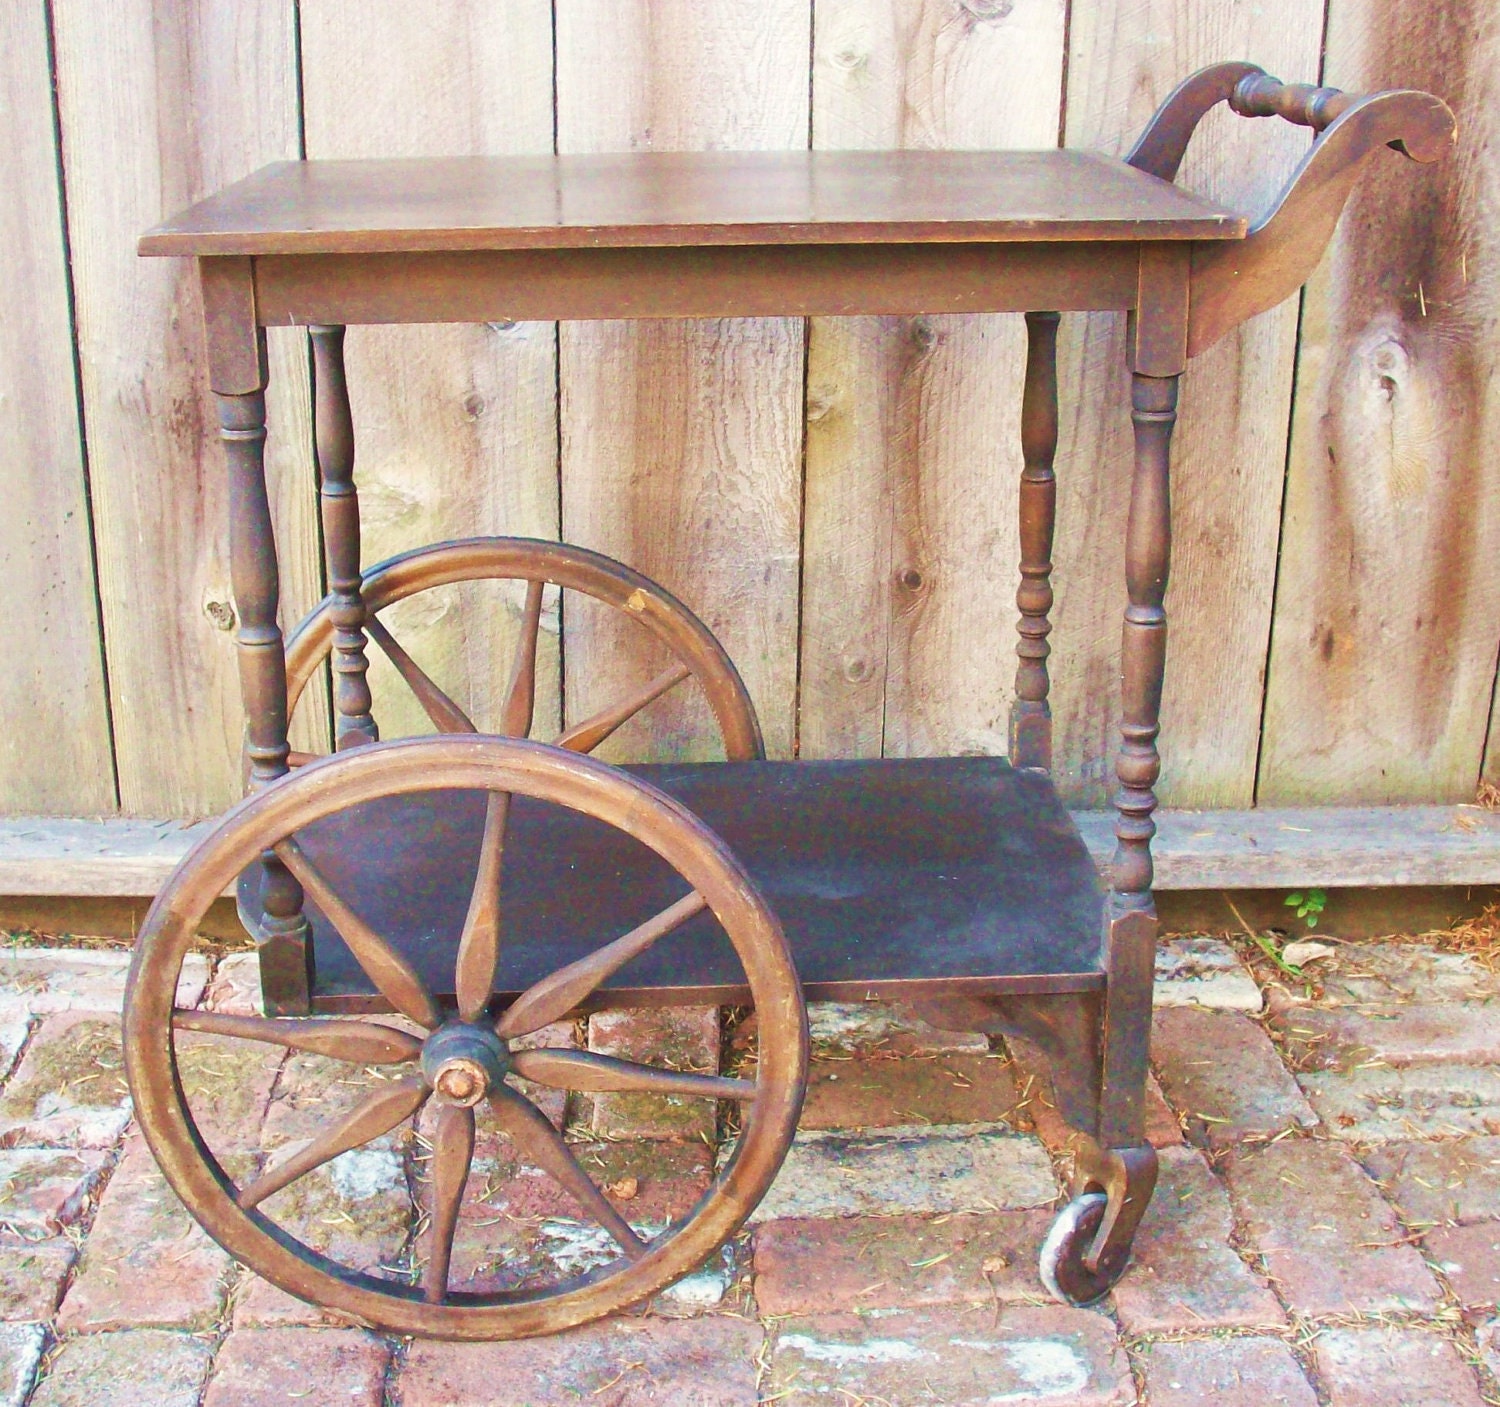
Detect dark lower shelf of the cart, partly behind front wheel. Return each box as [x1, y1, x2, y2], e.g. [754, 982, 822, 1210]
[242, 758, 1103, 1011]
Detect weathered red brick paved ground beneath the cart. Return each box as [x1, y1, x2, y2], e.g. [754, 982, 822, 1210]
[0, 938, 1500, 1407]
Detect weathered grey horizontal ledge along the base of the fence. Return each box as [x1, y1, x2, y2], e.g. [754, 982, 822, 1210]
[0, 806, 1500, 897]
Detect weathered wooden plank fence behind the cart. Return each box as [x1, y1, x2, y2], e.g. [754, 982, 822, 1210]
[0, 0, 1500, 818]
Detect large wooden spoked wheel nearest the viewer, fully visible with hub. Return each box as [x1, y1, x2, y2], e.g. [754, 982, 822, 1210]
[125, 737, 807, 1340]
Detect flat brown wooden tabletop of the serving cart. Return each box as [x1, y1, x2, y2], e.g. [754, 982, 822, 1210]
[140, 150, 1247, 255]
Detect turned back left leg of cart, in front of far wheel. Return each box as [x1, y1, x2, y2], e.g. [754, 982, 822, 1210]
[309, 327, 380, 752]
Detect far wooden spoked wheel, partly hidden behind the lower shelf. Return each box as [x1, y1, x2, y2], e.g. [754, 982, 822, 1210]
[287, 537, 765, 767]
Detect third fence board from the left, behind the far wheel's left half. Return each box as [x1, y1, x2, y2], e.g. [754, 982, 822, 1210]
[302, 0, 561, 738]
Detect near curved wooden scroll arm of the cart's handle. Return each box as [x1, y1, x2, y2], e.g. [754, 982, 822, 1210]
[1188, 86, 1457, 357]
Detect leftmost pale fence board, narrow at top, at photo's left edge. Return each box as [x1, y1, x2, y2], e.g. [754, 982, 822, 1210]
[0, 5, 116, 815]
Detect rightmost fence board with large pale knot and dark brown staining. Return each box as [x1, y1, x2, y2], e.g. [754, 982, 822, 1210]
[1260, 0, 1500, 804]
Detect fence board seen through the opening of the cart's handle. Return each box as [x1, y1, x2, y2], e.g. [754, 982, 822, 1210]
[1052, 0, 1322, 807]
